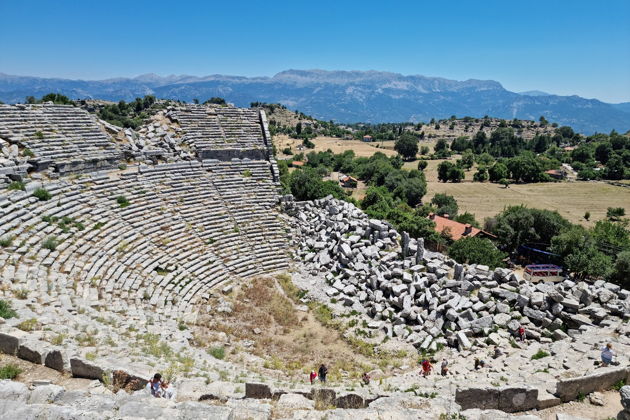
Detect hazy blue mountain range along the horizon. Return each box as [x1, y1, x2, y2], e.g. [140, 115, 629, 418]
[0, 70, 630, 134]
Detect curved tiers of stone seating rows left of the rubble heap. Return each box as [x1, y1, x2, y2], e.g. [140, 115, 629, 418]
[0, 104, 288, 315]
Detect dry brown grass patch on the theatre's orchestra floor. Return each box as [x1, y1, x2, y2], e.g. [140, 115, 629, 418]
[195, 275, 414, 381]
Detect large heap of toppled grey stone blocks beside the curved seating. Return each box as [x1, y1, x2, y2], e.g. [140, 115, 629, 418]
[285, 197, 630, 351]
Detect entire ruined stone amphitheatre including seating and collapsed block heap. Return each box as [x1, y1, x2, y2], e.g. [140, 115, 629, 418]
[0, 104, 630, 420]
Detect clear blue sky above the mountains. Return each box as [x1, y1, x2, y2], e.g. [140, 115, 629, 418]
[0, 0, 630, 102]
